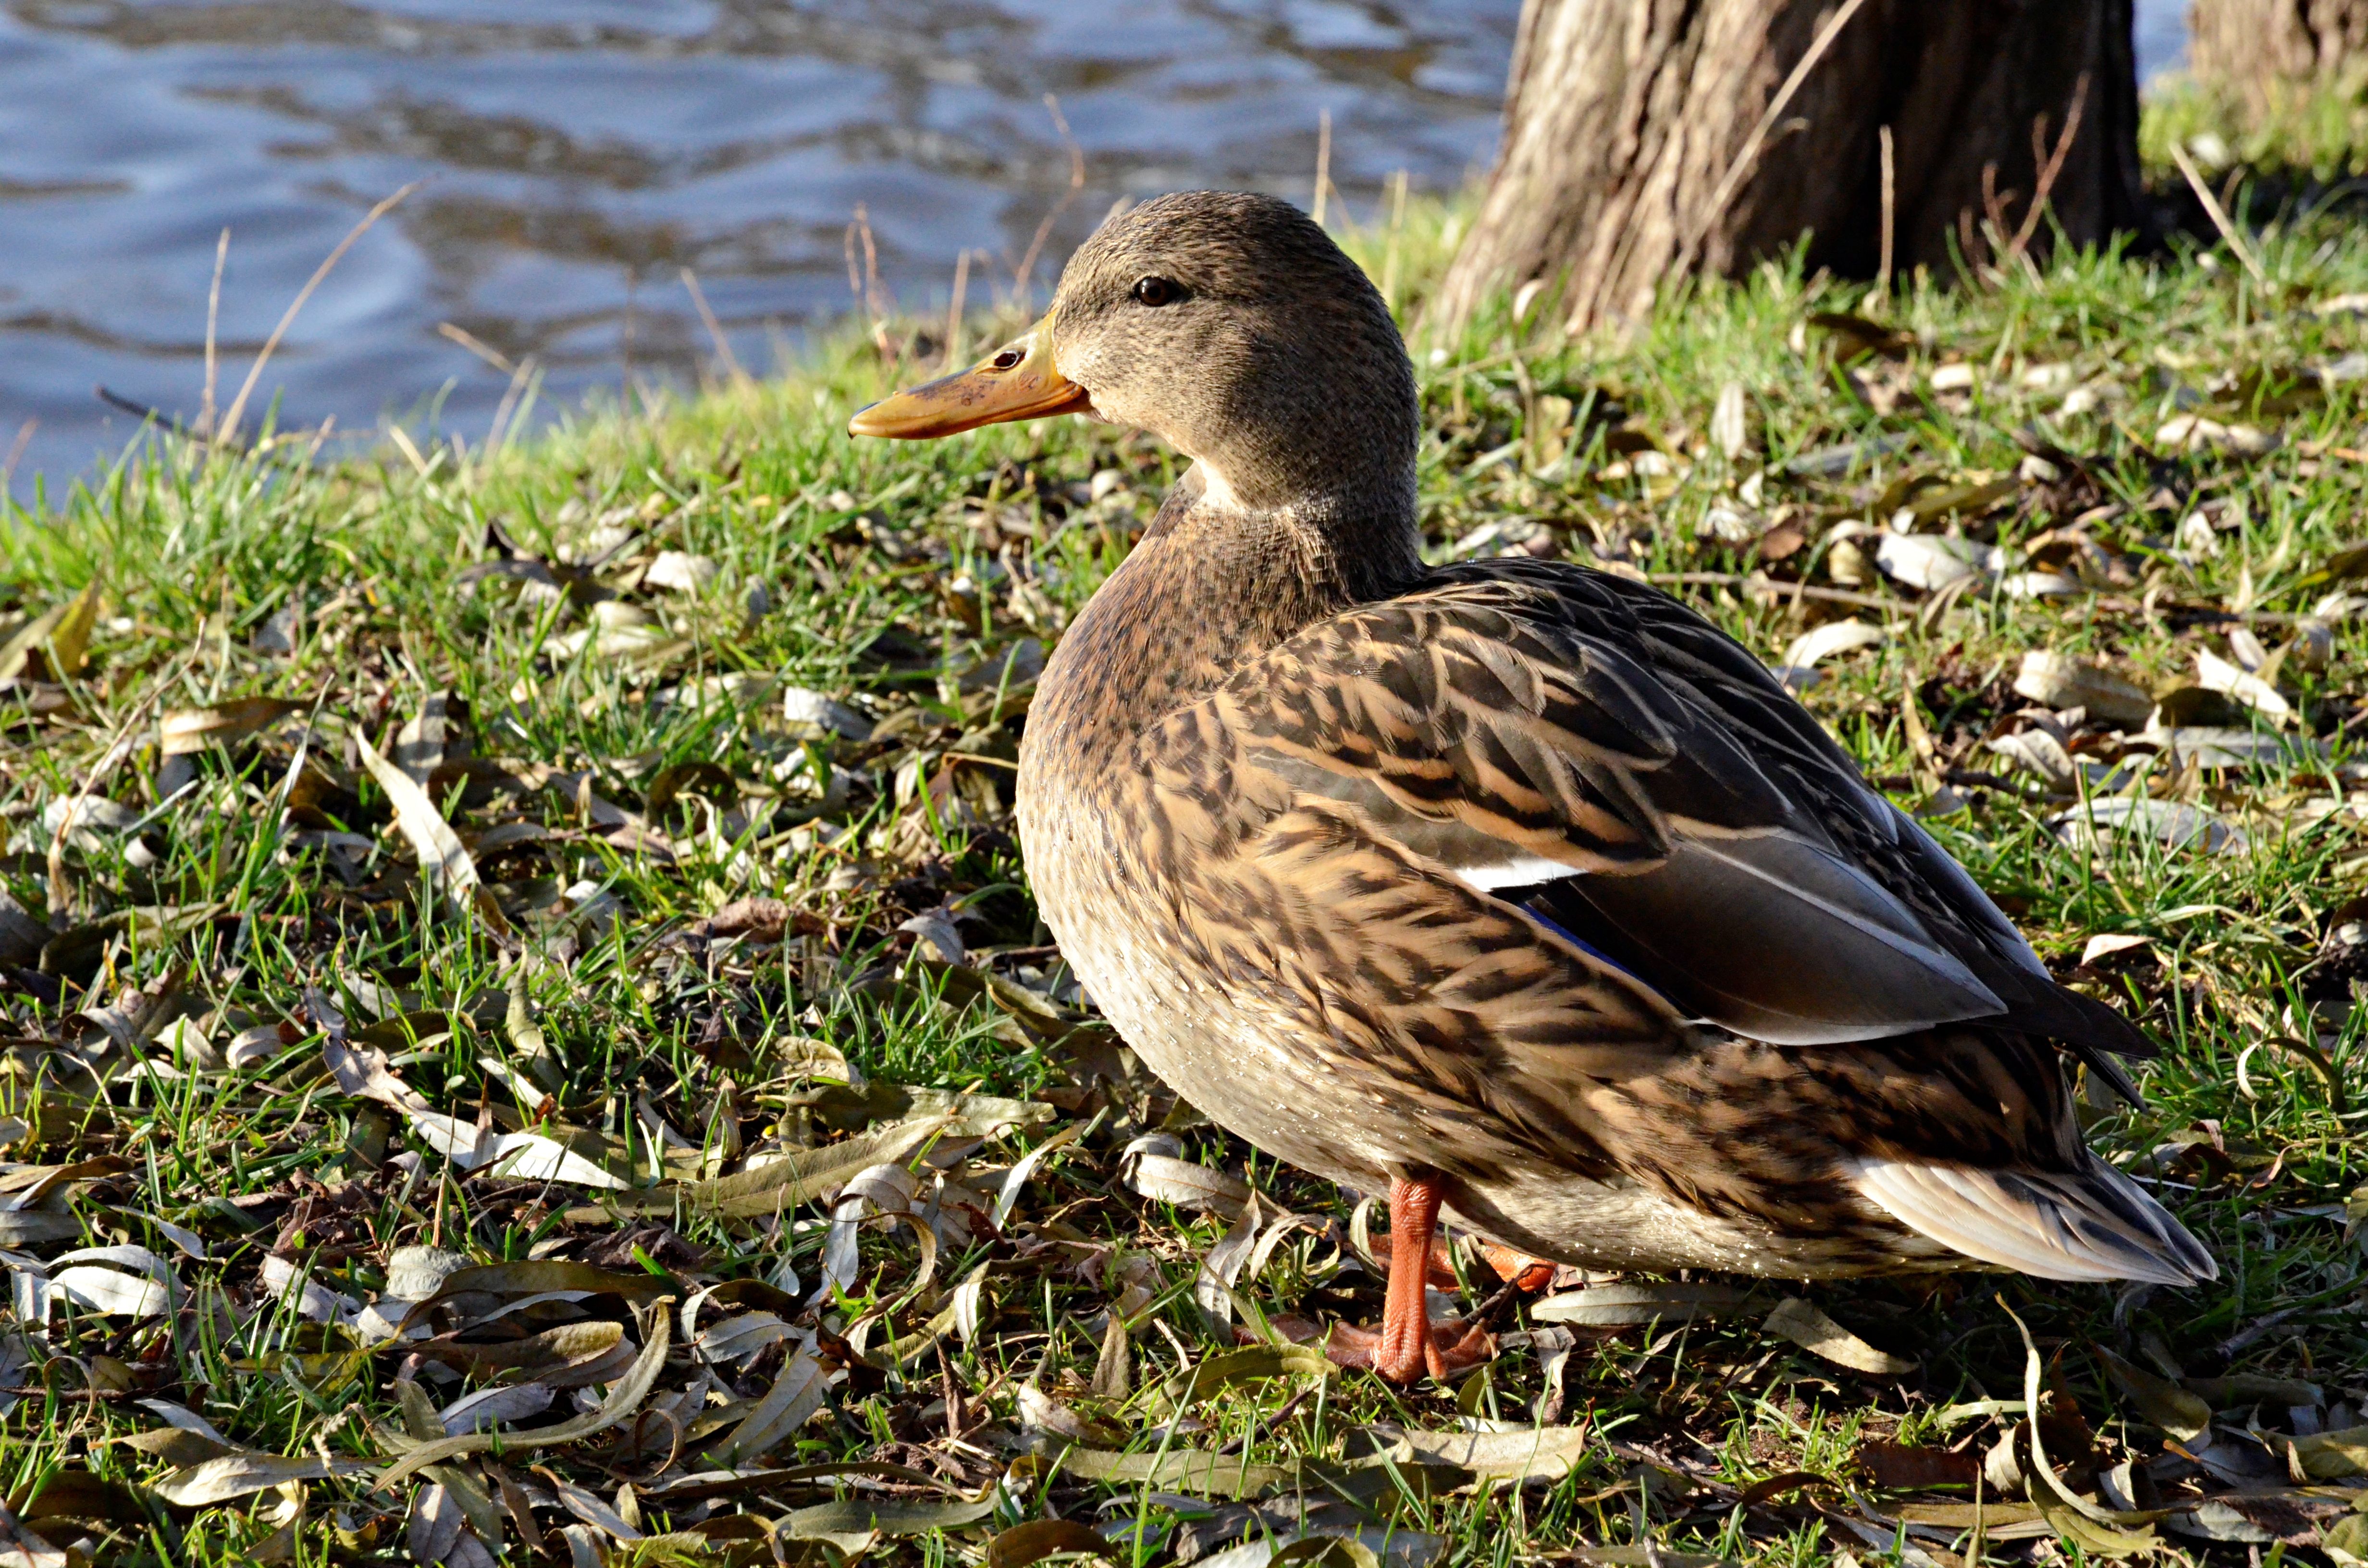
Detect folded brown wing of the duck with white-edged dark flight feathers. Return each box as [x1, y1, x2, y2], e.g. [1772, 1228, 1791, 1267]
[1208, 562, 2146, 1090]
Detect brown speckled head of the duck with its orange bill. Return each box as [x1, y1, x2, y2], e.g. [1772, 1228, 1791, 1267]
[848, 192, 1418, 528]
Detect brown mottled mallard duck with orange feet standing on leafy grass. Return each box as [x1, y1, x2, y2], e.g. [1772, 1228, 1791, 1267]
[850, 192, 2217, 1381]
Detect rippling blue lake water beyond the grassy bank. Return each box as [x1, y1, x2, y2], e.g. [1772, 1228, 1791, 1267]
[0, 0, 2181, 495]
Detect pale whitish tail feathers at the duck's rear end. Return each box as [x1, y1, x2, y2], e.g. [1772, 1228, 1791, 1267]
[1850, 1156, 2219, 1284]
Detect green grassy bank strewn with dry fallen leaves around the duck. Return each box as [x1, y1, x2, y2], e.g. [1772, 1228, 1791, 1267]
[0, 184, 2368, 1568]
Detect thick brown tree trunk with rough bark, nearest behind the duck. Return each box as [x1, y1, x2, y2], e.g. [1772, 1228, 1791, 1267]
[1435, 0, 2141, 331]
